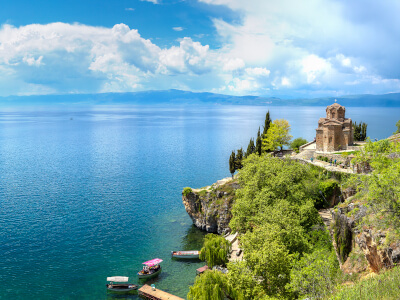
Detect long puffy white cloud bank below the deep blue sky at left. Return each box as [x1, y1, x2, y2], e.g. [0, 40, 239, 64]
[0, 23, 223, 95]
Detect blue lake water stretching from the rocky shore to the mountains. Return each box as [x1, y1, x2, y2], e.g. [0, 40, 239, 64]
[0, 106, 400, 299]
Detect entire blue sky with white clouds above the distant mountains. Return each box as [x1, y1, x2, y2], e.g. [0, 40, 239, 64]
[0, 0, 400, 98]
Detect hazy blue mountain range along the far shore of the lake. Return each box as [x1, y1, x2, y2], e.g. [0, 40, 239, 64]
[0, 90, 400, 107]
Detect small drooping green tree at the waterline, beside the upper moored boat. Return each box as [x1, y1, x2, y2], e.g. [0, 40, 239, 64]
[200, 233, 231, 268]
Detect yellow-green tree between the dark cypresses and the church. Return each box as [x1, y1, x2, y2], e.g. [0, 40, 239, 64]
[262, 119, 292, 151]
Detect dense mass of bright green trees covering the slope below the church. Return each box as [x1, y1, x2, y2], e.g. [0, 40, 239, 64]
[227, 155, 338, 299]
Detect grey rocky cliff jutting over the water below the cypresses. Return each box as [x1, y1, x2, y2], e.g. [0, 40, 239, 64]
[182, 178, 239, 234]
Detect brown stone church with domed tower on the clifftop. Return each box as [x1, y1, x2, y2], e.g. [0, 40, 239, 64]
[316, 103, 353, 152]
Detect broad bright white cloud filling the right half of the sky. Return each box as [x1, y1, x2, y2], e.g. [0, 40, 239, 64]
[199, 0, 400, 93]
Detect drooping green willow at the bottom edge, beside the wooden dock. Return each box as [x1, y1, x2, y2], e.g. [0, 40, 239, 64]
[187, 270, 244, 300]
